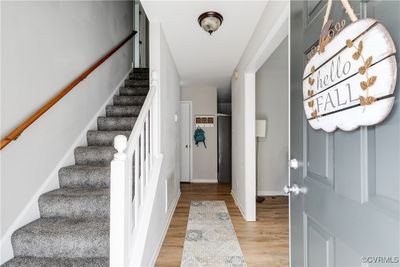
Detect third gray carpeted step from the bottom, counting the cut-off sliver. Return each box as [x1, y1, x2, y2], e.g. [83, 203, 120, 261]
[39, 188, 110, 218]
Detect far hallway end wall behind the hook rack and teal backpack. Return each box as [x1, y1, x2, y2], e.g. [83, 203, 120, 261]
[181, 87, 218, 183]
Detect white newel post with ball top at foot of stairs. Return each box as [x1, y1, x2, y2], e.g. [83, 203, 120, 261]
[110, 135, 128, 267]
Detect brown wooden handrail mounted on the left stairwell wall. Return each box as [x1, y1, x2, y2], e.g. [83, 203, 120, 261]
[0, 31, 136, 150]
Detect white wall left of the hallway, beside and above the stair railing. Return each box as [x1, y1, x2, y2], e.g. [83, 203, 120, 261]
[142, 21, 180, 266]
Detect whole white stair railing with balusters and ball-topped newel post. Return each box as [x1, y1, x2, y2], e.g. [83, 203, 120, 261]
[110, 71, 160, 267]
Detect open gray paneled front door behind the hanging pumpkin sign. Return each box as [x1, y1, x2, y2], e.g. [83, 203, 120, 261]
[290, 0, 400, 267]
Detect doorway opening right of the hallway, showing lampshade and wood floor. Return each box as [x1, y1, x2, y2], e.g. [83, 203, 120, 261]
[253, 37, 289, 266]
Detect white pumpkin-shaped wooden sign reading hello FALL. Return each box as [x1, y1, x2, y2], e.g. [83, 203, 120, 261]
[303, 19, 397, 132]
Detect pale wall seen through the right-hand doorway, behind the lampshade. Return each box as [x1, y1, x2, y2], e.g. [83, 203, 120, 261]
[256, 38, 289, 195]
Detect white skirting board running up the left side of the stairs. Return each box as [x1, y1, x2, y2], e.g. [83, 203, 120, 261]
[0, 69, 132, 265]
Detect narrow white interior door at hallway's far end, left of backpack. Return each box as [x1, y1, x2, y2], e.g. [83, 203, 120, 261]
[180, 102, 192, 182]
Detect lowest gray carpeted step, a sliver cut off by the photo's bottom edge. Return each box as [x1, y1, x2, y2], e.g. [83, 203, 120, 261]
[3, 257, 109, 267]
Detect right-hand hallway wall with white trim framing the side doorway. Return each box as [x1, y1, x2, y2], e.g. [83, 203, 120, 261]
[232, 1, 289, 221]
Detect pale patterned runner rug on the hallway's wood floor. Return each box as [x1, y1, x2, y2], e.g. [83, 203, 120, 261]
[181, 201, 247, 267]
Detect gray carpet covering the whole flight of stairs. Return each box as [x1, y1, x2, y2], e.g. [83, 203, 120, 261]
[2, 68, 149, 267]
